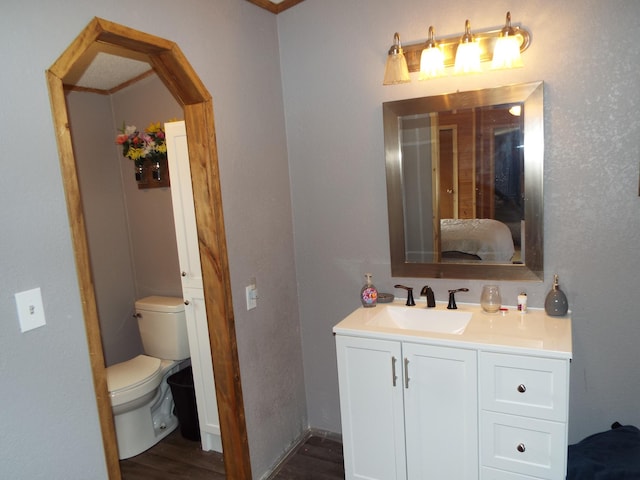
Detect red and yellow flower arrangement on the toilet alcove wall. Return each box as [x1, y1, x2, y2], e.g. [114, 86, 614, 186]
[116, 122, 167, 164]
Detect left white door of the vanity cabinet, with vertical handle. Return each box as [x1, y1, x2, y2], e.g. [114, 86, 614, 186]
[336, 335, 404, 480]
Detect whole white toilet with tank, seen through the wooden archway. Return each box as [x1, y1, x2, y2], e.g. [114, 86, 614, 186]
[107, 296, 189, 460]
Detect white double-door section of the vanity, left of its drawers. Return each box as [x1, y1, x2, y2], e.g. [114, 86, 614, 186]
[336, 335, 478, 480]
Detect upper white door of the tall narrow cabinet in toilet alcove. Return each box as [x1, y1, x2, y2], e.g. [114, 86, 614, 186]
[165, 121, 202, 288]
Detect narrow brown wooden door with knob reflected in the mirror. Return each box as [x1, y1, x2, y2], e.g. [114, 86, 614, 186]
[438, 126, 458, 218]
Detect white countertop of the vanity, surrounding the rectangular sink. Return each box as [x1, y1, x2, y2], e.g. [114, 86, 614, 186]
[333, 300, 572, 359]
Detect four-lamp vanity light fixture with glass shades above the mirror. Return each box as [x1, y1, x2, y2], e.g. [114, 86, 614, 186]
[384, 12, 531, 85]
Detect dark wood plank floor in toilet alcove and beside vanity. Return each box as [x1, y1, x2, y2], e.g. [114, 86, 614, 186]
[120, 429, 344, 480]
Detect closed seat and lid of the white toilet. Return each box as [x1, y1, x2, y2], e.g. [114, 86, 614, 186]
[106, 355, 162, 407]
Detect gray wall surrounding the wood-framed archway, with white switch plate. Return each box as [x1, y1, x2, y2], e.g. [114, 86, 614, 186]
[0, 0, 308, 480]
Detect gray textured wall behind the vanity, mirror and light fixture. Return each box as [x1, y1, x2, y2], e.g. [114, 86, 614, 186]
[278, 0, 640, 441]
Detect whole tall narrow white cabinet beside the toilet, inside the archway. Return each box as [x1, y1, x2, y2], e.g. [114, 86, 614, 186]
[165, 121, 222, 452]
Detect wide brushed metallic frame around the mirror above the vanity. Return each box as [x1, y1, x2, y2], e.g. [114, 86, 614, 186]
[382, 81, 544, 282]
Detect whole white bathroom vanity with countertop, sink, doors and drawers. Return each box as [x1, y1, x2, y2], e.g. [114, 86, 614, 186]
[333, 302, 572, 480]
